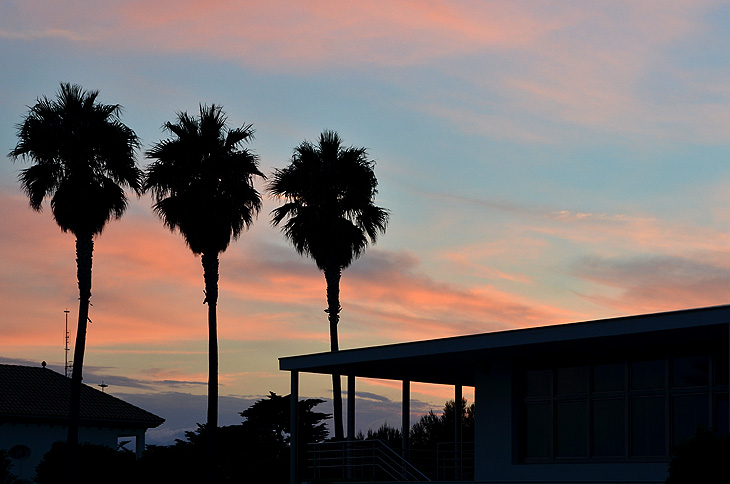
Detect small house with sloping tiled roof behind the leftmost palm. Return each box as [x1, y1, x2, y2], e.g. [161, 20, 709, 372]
[0, 365, 165, 480]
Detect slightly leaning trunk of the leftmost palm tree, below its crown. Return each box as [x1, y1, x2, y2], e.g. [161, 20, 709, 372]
[66, 233, 94, 484]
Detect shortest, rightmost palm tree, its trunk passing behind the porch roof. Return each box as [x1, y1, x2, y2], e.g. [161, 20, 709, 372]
[268, 131, 388, 440]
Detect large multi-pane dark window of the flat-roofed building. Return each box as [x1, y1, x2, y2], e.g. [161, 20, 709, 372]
[516, 352, 728, 462]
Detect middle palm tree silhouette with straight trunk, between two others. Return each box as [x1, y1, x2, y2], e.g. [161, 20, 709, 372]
[144, 104, 264, 479]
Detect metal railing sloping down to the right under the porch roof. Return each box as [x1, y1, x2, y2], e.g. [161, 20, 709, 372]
[308, 440, 431, 482]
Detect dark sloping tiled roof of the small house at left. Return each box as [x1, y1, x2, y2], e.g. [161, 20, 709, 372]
[0, 364, 165, 428]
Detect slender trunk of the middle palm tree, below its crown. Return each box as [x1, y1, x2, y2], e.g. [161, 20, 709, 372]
[201, 252, 219, 484]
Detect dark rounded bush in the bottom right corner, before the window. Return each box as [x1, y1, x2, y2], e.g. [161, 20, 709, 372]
[666, 428, 730, 484]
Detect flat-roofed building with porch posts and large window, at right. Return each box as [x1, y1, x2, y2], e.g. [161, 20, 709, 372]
[279, 306, 730, 484]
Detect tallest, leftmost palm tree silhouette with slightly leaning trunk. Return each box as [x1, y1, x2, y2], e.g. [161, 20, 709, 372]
[9, 83, 142, 478]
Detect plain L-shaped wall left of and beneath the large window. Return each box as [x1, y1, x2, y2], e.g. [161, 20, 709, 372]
[474, 360, 667, 484]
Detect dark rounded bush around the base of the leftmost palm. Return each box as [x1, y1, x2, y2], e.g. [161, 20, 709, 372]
[35, 442, 136, 484]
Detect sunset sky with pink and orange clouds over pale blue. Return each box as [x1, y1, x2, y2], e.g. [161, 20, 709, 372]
[0, 0, 730, 443]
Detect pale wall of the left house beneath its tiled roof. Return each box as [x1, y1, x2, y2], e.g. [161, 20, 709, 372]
[0, 423, 144, 480]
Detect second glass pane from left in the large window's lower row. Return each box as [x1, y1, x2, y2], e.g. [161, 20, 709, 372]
[555, 401, 588, 457]
